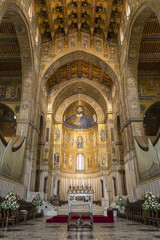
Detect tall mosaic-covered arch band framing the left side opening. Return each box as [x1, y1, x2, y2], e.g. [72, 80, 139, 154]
[0, 0, 35, 124]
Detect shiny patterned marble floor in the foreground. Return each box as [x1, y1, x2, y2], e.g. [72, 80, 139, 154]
[0, 217, 160, 240]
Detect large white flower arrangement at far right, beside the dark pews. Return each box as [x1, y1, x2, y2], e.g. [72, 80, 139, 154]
[142, 192, 160, 212]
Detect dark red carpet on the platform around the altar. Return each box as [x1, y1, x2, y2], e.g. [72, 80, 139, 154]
[46, 211, 114, 223]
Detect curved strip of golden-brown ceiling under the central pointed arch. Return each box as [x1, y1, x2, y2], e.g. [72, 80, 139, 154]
[47, 60, 112, 88]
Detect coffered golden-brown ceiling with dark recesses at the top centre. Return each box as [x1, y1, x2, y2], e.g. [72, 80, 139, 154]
[35, 0, 125, 42]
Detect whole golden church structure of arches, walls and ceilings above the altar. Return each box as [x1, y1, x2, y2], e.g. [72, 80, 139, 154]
[0, 0, 160, 210]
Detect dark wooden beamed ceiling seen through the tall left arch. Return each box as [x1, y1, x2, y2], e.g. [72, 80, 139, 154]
[0, 17, 22, 76]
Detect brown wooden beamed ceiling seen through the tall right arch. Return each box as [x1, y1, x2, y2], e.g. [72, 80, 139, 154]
[138, 14, 160, 73]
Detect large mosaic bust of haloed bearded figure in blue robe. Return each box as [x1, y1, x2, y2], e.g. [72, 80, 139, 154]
[64, 105, 95, 129]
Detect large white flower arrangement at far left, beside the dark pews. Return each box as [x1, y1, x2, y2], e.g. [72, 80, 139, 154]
[1, 191, 20, 210]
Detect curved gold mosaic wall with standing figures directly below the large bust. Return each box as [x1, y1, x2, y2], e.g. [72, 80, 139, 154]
[61, 126, 99, 172]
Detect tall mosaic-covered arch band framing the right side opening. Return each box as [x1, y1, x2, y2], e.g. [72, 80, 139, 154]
[123, 1, 160, 120]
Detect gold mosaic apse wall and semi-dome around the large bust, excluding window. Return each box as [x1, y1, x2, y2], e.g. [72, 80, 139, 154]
[53, 101, 108, 173]
